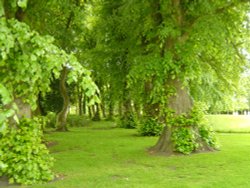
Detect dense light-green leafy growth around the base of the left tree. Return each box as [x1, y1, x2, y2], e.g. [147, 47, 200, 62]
[0, 119, 54, 185]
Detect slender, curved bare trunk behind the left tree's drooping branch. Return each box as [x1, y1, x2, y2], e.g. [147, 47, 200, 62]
[56, 67, 70, 131]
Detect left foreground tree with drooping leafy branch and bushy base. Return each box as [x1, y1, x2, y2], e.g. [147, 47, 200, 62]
[0, 0, 98, 184]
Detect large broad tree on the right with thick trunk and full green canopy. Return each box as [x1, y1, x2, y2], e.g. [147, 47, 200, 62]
[87, 0, 249, 154]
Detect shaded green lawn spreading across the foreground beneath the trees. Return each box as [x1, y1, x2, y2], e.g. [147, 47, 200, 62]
[16, 117, 250, 188]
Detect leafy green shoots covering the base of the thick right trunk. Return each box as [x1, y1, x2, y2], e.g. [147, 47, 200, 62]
[167, 105, 218, 154]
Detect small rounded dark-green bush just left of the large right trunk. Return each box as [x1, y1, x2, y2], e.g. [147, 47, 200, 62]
[138, 118, 164, 136]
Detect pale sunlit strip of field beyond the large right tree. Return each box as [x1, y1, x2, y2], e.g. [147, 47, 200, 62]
[207, 115, 250, 133]
